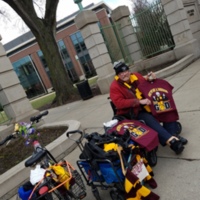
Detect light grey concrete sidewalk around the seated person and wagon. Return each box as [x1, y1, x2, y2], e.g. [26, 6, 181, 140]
[38, 60, 200, 200]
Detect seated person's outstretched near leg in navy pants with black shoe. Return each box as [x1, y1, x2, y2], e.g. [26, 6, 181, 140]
[137, 111, 184, 154]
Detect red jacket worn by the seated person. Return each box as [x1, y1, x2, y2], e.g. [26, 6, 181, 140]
[110, 73, 145, 116]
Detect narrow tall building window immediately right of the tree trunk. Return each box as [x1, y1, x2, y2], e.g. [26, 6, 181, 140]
[58, 40, 79, 82]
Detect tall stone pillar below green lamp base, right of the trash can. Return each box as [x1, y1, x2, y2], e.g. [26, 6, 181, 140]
[75, 10, 114, 94]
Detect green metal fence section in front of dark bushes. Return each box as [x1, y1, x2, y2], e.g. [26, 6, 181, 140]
[130, 0, 175, 58]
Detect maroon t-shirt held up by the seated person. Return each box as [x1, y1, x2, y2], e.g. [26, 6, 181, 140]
[138, 79, 179, 122]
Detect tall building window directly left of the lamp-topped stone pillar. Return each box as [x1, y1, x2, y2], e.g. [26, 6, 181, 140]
[70, 31, 96, 78]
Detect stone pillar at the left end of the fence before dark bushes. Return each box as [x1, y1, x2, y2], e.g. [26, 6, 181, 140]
[111, 6, 142, 63]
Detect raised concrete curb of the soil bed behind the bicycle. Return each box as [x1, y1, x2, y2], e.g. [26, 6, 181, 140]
[0, 120, 81, 200]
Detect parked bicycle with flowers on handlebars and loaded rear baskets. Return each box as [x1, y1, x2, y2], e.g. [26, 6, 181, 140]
[0, 111, 86, 200]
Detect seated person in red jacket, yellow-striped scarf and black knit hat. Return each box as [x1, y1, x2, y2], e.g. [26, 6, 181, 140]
[110, 62, 187, 154]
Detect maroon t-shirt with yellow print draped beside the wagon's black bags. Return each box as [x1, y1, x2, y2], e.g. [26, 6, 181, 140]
[108, 120, 159, 151]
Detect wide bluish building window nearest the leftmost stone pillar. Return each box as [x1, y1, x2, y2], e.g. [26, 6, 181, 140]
[12, 56, 46, 99]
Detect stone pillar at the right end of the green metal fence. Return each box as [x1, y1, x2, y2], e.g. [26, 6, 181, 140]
[161, 0, 200, 59]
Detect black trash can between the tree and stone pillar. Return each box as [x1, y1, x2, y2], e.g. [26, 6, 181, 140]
[76, 80, 93, 100]
